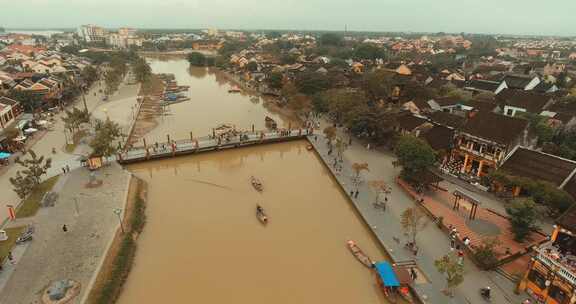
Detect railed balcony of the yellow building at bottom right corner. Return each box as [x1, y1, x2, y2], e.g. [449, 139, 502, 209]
[536, 243, 576, 286]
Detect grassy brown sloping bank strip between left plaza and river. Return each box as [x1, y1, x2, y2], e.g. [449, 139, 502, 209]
[83, 177, 148, 304]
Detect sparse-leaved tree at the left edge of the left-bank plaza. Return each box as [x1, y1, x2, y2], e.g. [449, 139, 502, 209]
[10, 150, 52, 199]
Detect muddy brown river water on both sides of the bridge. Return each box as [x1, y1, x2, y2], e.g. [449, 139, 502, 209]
[118, 60, 386, 304]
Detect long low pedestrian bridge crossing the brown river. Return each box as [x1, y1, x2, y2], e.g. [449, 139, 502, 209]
[116, 129, 313, 164]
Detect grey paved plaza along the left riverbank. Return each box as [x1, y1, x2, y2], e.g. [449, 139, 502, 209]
[0, 164, 130, 304]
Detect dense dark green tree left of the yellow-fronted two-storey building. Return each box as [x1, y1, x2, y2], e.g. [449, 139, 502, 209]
[394, 135, 436, 182]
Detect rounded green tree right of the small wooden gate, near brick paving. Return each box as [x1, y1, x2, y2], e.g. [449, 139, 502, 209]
[506, 198, 536, 242]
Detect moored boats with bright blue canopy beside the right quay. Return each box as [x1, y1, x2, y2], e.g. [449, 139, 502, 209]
[346, 240, 416, 303]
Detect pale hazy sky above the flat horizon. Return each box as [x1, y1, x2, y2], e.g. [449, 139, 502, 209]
[0, 0, 576, 35]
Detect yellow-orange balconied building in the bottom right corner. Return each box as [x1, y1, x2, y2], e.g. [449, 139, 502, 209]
[518, 207, 576, 304]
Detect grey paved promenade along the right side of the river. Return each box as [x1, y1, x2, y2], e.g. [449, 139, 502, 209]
[311, 127, 525, 304]
